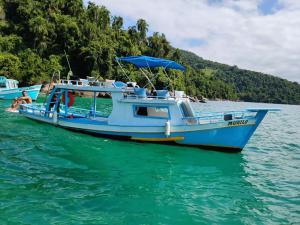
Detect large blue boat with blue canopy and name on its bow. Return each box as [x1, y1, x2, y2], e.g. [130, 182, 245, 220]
[19, 56, 278, 152]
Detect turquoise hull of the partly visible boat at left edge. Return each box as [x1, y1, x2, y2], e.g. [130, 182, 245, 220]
[0, 85, 42, 101]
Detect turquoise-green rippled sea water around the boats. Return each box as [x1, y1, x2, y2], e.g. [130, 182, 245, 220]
[0, 99, 300, 225]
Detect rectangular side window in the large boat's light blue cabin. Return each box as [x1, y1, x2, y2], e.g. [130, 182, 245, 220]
[134, 106, 169, 119]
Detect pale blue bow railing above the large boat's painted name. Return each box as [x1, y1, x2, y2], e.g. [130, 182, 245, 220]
[182, 110, 257, 125]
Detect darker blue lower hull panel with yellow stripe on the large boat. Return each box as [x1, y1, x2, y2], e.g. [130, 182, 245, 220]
[86, 125, 257, 152]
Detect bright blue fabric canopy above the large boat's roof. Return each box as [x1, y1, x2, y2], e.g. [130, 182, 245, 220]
[116, 56, 185, 71]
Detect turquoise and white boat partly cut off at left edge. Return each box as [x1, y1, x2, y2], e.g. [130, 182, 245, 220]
[0, 76, 42, 101]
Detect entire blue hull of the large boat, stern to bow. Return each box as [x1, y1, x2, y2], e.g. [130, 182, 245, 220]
[20, 110, 268, 152]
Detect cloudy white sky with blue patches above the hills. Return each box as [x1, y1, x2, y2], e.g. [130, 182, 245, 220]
[85, 0, 300, 83]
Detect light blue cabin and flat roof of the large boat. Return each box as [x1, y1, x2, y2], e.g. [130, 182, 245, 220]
[56, 80, 195, 126]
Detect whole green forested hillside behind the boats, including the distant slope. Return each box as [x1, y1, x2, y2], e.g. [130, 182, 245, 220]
[0, 0, 300, 104]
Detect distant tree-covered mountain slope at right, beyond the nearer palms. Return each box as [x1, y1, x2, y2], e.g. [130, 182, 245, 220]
[180, 50, 300, 104]
